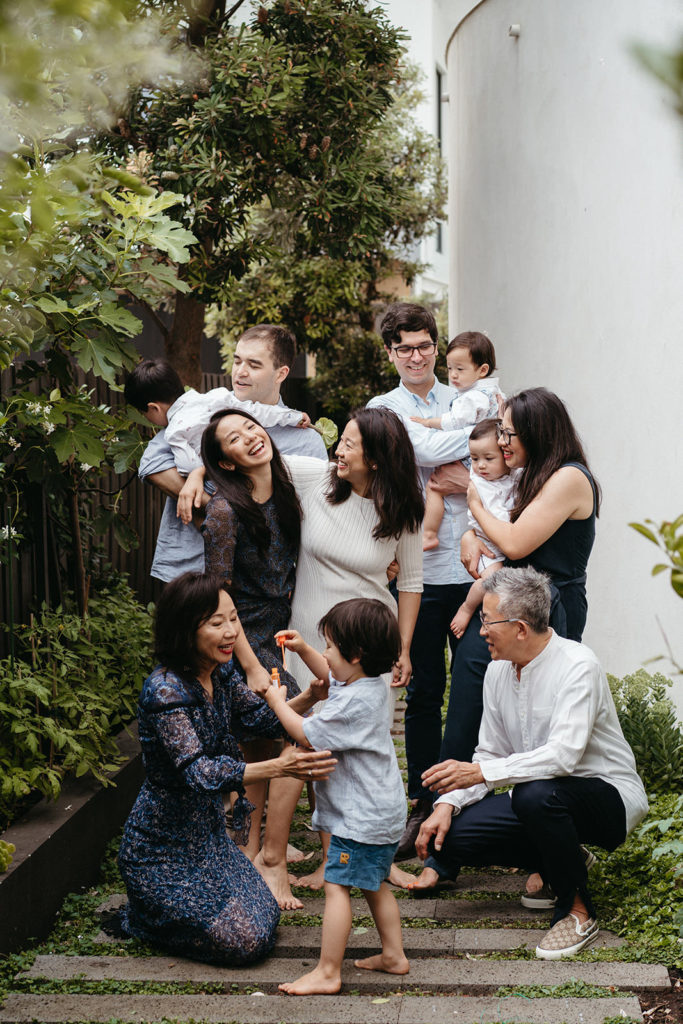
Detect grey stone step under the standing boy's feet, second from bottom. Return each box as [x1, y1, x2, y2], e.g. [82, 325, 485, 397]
[22, 955, 671, 992]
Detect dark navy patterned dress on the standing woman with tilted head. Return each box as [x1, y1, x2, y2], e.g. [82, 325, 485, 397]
[202, 495, 300, 697]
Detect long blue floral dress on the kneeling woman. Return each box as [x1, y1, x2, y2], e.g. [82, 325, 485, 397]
[119, 663, 282, 966]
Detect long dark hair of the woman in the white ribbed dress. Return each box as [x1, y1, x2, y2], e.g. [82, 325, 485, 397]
[327, 408, 425, 541]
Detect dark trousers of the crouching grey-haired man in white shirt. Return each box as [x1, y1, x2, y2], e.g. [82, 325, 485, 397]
[427, 776, 626, 925]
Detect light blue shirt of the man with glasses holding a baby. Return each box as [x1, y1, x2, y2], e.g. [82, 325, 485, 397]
[368, 378, 472, 585]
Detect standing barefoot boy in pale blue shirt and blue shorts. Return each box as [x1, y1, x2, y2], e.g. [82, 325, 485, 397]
[265, 599, 410, 995]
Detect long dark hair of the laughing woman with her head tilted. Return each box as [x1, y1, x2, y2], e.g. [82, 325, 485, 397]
[202, 409, 302, 555]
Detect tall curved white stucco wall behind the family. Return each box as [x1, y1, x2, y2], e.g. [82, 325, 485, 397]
[447, 0, 683, 712]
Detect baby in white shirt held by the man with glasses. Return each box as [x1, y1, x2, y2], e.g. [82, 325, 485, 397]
[411, 331, 503, 551]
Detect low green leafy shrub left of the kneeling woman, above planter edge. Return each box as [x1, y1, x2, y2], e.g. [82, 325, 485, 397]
[0, 579, 152, 821]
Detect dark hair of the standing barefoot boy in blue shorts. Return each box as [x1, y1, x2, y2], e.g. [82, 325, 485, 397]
[317, 597, 400, 676]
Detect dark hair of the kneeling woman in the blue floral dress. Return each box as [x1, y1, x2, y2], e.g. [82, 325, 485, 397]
[155, 572, 230, 677]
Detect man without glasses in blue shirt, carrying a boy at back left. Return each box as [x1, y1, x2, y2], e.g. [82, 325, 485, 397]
[138, 324, 328, 582]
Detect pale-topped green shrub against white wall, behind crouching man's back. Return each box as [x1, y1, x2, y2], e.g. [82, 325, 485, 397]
[607, 669, 683, 793]
